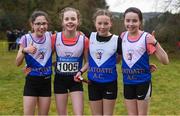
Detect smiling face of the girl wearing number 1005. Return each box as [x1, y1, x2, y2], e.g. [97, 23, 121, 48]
[62, 11, 79, 31]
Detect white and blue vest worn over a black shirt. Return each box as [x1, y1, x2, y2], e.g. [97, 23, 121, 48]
[88, 32, 118, 83]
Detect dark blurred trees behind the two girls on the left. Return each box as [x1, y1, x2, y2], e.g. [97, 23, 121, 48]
[0, 0, 108, 33]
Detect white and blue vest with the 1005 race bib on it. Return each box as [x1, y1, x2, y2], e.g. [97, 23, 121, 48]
[55, 32, 85, 76]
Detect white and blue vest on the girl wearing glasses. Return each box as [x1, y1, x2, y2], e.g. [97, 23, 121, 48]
[25, 32, 52, 76]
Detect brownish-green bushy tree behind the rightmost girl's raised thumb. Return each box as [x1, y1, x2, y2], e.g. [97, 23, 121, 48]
[144, 12, 180, 48]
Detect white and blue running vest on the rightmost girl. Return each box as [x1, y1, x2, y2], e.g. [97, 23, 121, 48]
[122, 32, 151, 84]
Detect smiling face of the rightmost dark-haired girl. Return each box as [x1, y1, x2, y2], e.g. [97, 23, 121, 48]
[124, 12, 141, 34]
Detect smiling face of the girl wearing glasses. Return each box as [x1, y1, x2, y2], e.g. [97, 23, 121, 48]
[31, 16, 48, 37]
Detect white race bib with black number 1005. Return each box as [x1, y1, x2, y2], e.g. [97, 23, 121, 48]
[57, 62, 79, 72]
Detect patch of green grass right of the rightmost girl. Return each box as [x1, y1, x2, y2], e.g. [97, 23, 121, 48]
[150, 52, 180, 115]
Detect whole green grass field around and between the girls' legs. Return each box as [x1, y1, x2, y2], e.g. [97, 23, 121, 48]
[0, 41, 180, 115]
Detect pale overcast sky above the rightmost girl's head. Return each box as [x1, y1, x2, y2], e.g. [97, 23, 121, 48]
[106, 0, 177, 12]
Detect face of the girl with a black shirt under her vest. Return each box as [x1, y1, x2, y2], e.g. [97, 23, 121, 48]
[95, 15, 112, 37]
